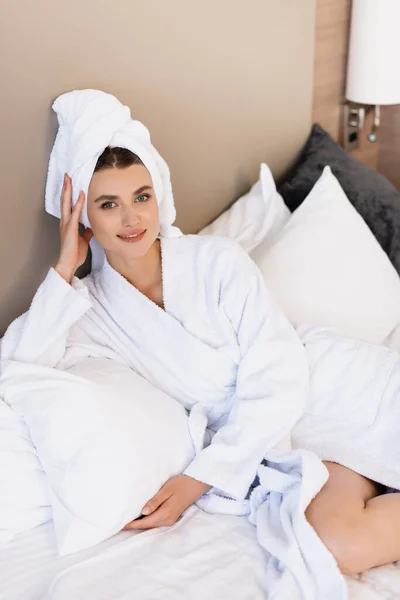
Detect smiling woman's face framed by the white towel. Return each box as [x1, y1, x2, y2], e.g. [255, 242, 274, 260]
[87, 164, 160, 259]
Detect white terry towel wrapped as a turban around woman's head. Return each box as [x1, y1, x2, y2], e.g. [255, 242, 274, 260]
[45, 90, 182, 270]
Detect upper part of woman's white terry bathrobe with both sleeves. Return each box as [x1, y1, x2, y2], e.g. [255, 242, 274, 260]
[1, 236, 308, 499]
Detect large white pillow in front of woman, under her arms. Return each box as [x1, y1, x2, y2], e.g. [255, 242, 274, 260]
[0, 359, 194, 555]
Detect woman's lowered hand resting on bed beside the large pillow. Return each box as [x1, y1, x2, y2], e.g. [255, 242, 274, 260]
[124, 475, 211, 529]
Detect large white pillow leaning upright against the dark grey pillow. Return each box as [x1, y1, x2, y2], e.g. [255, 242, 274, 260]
[252, 167, 400, 343]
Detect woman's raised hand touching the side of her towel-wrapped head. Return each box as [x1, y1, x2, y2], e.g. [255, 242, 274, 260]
[54, 174, 93, 283]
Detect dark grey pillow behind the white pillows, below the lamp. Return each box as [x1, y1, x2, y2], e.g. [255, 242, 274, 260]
[278, 124, 400, 274]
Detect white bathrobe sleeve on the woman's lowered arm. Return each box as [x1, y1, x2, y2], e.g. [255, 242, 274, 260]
[185, 244, 309, 500]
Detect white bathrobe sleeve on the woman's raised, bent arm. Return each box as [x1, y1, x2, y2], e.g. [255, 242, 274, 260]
[0, 268, 91, 373]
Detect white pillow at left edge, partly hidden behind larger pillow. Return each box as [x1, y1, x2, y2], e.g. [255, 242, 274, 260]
[0, 400, 52, 547]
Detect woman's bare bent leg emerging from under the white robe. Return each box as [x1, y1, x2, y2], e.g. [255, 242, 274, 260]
[306, 462, 400, 574]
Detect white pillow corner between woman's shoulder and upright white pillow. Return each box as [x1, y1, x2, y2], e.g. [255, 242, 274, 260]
[199, 163, 290, 252]
